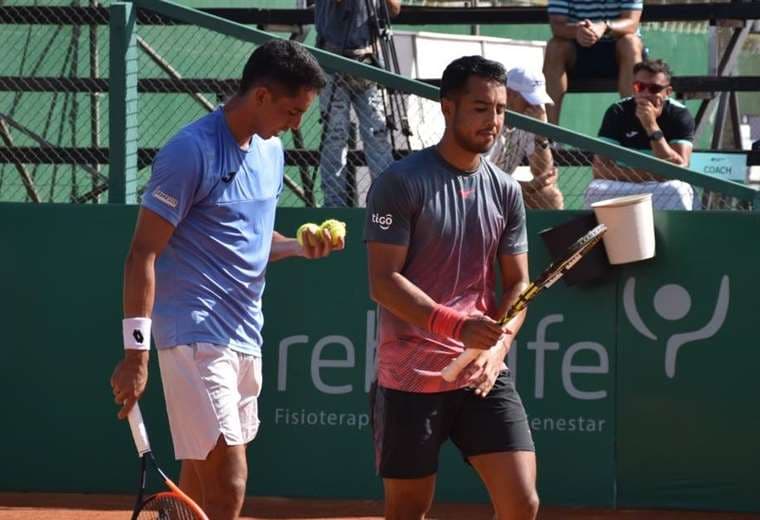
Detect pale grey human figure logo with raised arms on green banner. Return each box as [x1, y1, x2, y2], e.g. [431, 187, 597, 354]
[623, 275, 730, 379]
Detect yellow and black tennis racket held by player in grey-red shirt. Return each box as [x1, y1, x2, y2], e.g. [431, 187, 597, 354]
[441, 224, 607, 383]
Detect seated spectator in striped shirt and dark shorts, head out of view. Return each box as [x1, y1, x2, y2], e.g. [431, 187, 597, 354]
[544, 0, 644, 125]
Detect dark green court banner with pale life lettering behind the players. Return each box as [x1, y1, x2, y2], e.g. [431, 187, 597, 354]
[0, 204, 760, 512]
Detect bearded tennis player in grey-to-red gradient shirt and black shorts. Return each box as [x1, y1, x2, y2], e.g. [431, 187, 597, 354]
[365, 56, 538, 520]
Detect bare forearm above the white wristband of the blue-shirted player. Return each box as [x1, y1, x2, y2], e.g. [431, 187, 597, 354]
[123, 249, 156, 318]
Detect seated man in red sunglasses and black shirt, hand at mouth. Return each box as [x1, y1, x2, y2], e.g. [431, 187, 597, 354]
[586, 60, 694, 210]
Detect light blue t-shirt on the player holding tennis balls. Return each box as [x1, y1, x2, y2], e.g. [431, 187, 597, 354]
[142, 109, 284, 356]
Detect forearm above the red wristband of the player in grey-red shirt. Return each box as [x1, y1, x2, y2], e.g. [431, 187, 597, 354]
[370, 273, 436, 329]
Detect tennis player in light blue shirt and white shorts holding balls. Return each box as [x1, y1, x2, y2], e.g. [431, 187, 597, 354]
[111, 40, 343, 520]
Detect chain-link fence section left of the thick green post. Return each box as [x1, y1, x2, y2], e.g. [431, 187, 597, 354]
[0, 0, 109, 202]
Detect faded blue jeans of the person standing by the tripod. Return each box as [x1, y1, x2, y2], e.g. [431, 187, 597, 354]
[319, 74, 393, 207]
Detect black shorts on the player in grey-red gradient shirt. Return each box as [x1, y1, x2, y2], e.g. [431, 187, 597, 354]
[370, 370, 535, 478]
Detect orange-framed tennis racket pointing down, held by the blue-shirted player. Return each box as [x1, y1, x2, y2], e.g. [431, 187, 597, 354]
[128, 403, 208, 520]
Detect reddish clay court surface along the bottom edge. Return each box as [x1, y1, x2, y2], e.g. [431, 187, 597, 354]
[0, 493, 760, 520]
